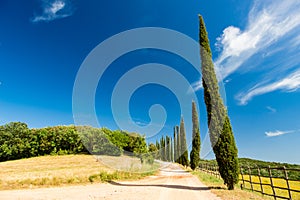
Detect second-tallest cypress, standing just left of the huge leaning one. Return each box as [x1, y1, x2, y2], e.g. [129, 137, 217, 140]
[190, 101, 201, 170]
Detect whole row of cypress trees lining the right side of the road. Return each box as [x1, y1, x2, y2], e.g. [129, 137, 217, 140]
[155, 15, 239, 190]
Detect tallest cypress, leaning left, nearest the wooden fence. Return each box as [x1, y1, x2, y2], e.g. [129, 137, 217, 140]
[199, 16, 239, 190]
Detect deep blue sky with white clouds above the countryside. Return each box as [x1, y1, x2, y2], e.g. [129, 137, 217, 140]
[0, 0, 300, 163]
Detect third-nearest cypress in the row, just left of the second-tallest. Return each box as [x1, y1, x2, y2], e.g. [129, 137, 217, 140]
[179, 117, 189, 166]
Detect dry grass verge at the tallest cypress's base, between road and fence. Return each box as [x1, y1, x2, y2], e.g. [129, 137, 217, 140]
[192, 171, 273, 200]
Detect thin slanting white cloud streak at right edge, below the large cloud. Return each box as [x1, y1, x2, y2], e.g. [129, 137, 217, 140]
[236, 69, 300, 105]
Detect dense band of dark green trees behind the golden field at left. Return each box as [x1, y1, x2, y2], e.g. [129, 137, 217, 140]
[0, 122, 148, 161]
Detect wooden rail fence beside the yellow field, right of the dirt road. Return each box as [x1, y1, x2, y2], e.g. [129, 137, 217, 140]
[199, 163, 300, 200]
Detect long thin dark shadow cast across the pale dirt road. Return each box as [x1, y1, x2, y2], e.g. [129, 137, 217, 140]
[108, 181, 224, 191]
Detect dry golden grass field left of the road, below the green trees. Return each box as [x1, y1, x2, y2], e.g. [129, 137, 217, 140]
[0, 155, 159, 190]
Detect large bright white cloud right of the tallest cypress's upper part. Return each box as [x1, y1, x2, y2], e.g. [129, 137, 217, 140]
[215, 0, 300, 78]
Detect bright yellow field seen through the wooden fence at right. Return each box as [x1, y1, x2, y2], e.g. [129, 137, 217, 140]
[240, 175, 300, 199]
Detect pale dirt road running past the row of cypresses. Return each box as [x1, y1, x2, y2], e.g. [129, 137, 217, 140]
[0, 164, 219, 200]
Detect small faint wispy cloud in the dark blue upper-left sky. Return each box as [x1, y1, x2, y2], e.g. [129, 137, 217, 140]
[32, 0, 73, 22]
